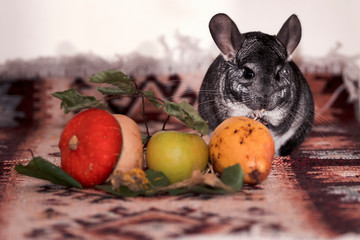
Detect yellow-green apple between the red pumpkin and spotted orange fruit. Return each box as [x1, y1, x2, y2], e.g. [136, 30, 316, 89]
[146, 131, 209, 183]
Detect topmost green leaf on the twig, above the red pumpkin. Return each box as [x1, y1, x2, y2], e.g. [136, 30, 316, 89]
[89, 70, 139, 95]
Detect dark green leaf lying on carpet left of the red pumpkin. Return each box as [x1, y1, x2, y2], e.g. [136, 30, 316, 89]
[15, 157, 82, 188]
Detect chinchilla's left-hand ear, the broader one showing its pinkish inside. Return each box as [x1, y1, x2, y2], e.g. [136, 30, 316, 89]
[209, 13, 244, 60]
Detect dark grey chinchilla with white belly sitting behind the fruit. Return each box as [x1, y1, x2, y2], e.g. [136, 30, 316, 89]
[198, 13, 314, 156]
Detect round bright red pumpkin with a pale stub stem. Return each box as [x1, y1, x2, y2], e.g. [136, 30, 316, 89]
[59, 109, 122, 187]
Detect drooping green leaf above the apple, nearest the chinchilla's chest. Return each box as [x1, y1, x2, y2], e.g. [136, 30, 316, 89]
[164, 100, 209, 135]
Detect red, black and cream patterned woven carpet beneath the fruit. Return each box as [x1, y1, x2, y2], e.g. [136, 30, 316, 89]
[0, 75, 360, 239]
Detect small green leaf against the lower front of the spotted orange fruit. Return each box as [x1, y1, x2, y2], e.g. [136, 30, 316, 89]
[220, 163, 244, 192]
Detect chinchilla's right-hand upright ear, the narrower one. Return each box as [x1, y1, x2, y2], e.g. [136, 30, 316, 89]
[276, 14, 301, 56]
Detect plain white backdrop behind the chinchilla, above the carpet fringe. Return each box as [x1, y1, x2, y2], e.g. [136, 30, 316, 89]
[0, 0, 360, 63]
